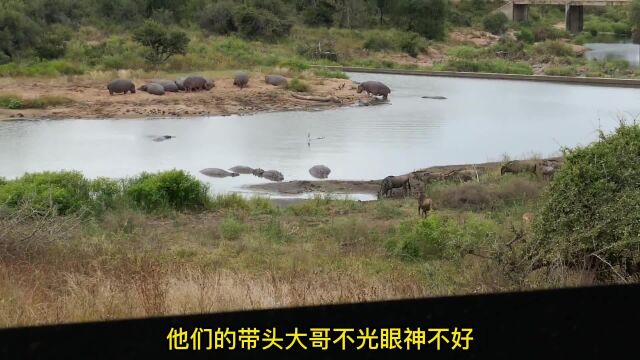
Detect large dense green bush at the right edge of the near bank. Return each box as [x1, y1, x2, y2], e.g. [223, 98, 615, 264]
[529, 123, 640, 275]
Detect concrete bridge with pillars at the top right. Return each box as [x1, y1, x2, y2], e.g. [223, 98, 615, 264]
[498, 0, 631, 33]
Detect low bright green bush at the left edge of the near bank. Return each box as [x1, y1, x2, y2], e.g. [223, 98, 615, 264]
[0, 171, 91, 215]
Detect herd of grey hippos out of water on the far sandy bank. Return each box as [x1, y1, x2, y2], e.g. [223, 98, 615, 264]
[107, 71, 391, 100]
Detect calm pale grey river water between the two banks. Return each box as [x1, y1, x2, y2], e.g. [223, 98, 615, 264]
[0, 74, 640, 198]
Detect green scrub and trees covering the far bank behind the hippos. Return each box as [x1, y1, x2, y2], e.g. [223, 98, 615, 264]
[0, 0, 640, 83]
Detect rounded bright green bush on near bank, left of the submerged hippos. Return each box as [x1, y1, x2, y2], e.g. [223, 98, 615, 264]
[126, 170, 209, 211]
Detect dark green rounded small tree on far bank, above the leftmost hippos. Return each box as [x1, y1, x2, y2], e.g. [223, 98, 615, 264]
[133, 20, 189, 66]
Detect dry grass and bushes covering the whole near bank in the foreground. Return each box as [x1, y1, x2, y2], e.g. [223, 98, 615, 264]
[0, 123, 640, 326]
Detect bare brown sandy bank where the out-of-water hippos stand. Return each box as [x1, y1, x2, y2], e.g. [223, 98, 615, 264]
[0, 74, 366, 119]
